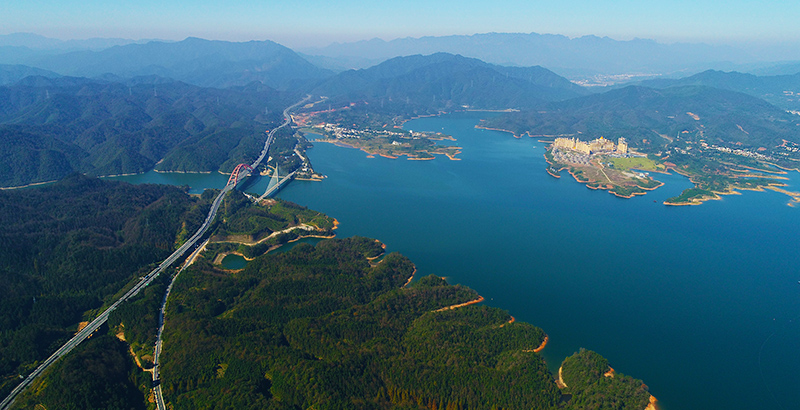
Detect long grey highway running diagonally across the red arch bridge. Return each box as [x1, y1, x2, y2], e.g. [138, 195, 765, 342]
[0, 95, 311, 410]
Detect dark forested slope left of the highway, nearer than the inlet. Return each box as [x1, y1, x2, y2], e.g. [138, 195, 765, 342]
[0, 174, 210, 400]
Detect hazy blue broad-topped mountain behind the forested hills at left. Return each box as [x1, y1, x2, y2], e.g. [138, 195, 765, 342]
[26, 37, 333, 88]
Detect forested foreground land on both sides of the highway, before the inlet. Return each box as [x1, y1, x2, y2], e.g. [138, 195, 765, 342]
[0, 175, 650, 410]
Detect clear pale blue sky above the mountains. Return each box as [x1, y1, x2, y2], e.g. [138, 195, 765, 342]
[0, 0, 800, 48]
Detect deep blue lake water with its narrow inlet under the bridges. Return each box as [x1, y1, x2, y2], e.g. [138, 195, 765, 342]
[108, 113, 800, 410]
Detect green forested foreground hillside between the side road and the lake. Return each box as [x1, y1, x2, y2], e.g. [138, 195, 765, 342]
[150, 237, 649, 410]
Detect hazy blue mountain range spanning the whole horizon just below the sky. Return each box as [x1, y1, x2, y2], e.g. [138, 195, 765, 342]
[6, 33, 800, 82]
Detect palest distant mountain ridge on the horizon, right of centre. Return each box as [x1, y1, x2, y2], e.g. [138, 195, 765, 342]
[298, 33, 754, 76]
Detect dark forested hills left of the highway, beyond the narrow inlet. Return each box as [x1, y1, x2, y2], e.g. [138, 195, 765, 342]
[0, 76, 296, 186]
